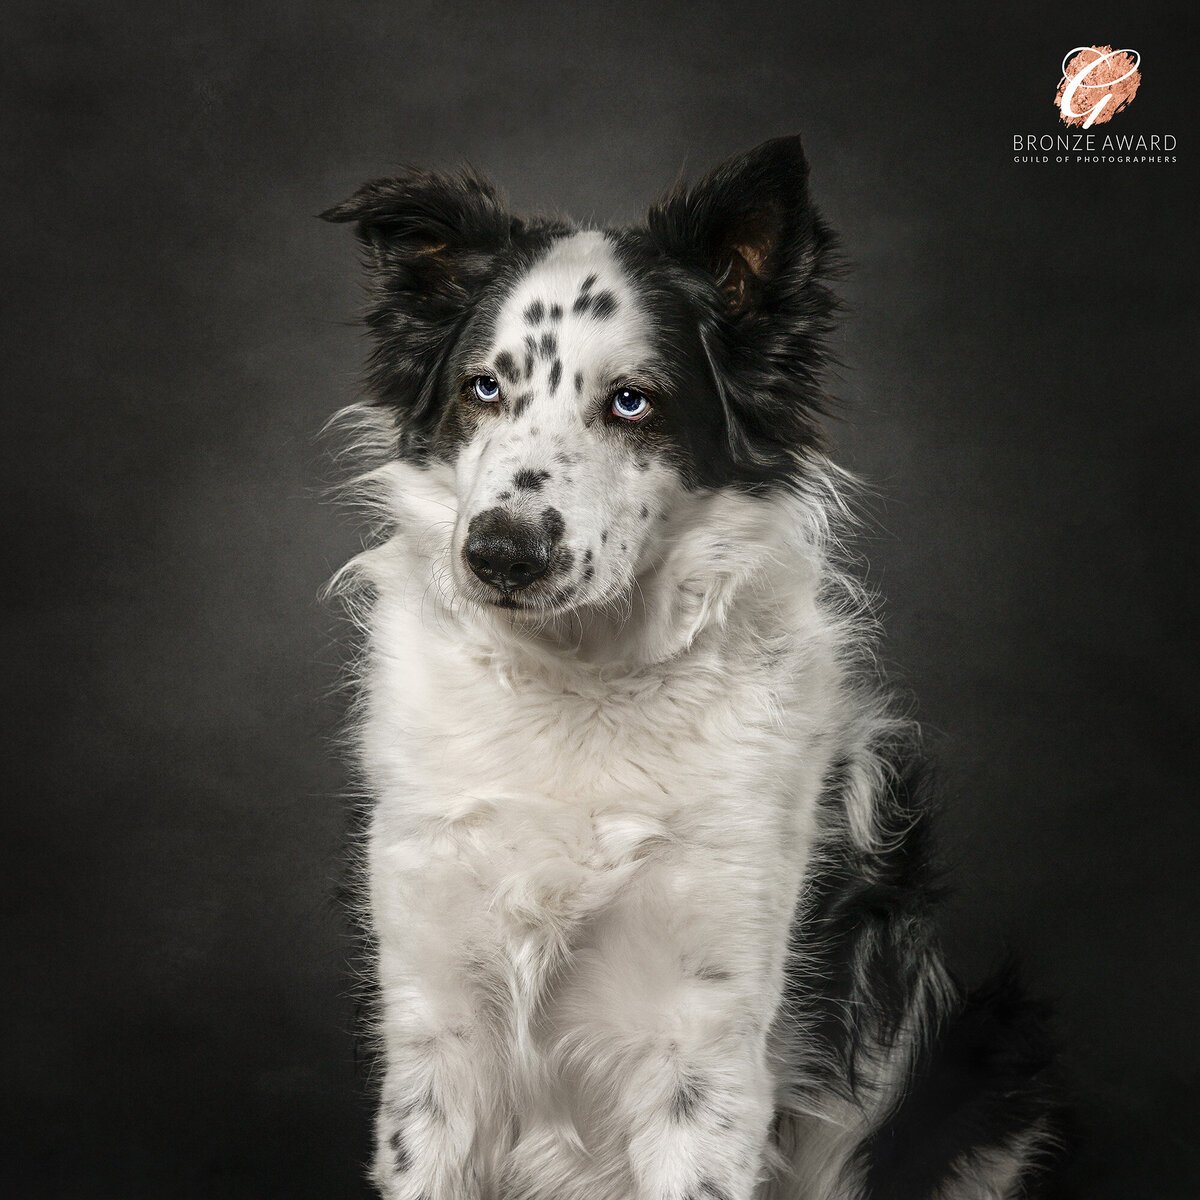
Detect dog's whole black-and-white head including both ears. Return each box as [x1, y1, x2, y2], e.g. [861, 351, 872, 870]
[324, 138, 834, 614]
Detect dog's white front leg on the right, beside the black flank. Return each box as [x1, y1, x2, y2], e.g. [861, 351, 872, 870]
[563, 863, 790, 1200]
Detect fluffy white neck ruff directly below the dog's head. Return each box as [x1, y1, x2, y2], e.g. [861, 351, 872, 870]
[335, 451, 850, 676]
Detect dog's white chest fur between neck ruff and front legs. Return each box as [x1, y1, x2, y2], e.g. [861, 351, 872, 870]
[362, 520, 834, 1020]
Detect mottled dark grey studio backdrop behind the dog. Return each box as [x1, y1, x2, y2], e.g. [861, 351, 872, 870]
[0, 0, 1200, 1200]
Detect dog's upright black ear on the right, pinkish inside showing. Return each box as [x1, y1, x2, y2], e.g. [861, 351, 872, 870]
[647, 137, 838, 479]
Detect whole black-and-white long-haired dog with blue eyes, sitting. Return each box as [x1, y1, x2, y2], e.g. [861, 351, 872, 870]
[324, 138, 1052, 1200]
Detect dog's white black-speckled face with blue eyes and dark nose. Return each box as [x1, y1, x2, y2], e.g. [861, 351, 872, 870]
[448, 233, 679, 612]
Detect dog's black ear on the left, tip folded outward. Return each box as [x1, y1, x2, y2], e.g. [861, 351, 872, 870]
[320, 170, 521, 432]
